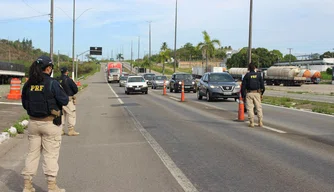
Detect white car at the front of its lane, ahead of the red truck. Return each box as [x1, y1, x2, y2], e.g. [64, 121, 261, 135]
[124, 76, 148, 95]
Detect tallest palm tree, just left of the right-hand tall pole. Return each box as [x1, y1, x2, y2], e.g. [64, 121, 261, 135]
[197, 31, 220, 72]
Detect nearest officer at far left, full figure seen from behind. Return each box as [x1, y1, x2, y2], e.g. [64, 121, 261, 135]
[22, 56, 69, 192]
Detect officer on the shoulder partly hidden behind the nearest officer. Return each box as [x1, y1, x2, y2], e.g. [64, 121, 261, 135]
[60, 67, 80, 136]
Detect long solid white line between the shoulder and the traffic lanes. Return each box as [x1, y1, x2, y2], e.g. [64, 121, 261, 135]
[107, 82, 198, 192]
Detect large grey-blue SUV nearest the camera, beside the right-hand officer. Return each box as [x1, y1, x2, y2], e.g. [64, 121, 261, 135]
[197, 72, 241, 101]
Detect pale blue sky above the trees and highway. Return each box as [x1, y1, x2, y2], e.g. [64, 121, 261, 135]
[0, 0, 334, 58]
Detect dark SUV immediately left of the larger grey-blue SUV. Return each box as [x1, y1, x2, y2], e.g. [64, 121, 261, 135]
[169, 73, 197, 93]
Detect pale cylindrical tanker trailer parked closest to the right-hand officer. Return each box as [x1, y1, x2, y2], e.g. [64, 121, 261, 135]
[264, 66, 306, 86]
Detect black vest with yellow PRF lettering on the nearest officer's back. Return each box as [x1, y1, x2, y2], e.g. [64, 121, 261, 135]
[25, 79, 59, 118]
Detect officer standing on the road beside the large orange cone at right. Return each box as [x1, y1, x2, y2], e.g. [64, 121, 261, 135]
[241, 63, 265, 127]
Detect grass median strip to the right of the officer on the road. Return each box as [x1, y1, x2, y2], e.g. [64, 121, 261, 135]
[262, 96, 334, 115]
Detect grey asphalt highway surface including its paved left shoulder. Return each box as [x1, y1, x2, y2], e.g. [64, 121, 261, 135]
[0, 67, 334, 192]
